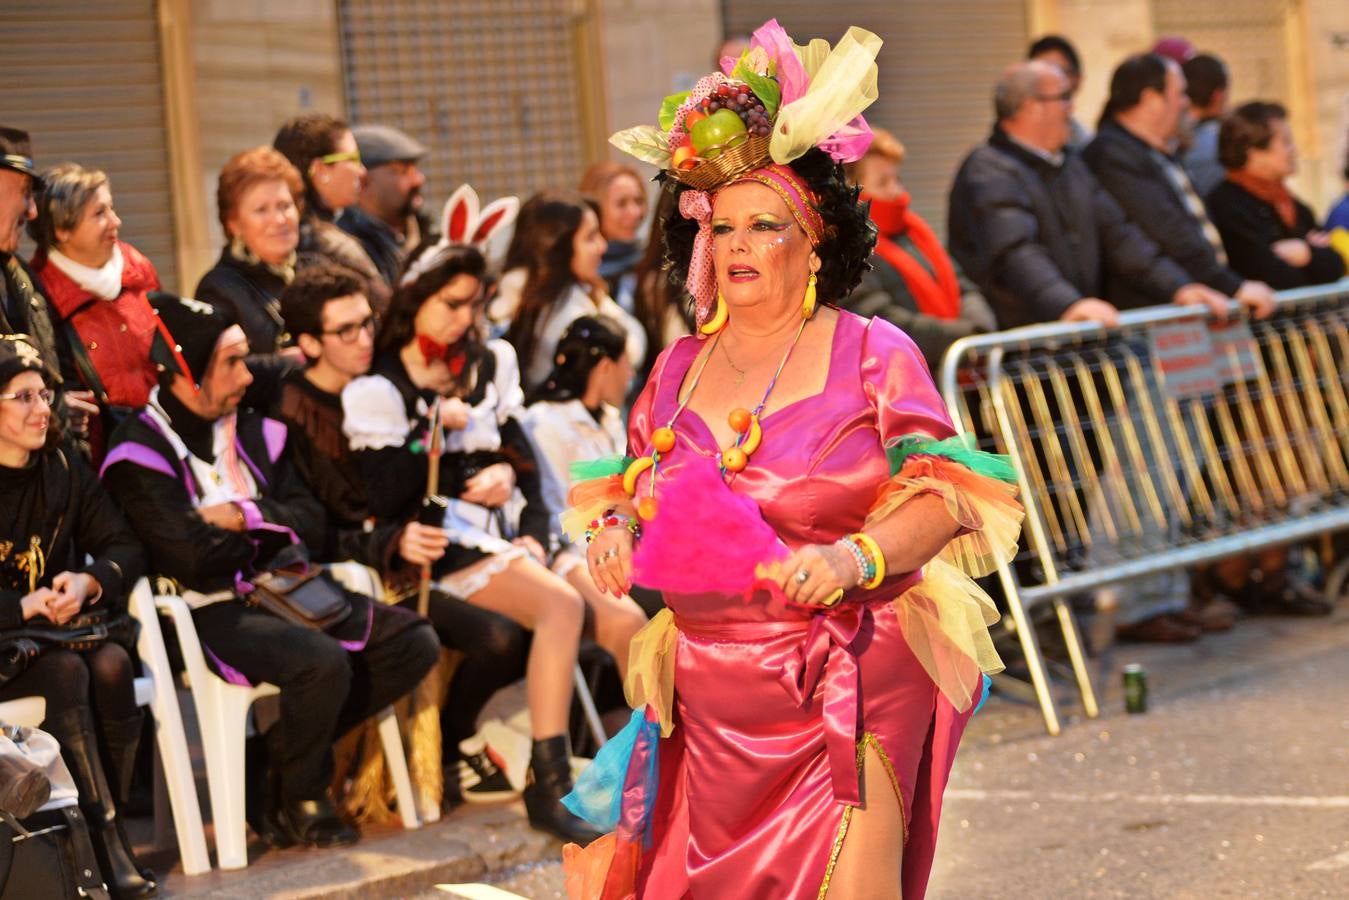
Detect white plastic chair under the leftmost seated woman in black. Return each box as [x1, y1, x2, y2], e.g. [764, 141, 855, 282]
[0, 579, 210, 874]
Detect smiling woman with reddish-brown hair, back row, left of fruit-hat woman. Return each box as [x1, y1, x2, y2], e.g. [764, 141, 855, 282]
[580, 161, 646, 313]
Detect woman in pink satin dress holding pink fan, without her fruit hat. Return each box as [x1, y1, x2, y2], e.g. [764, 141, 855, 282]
[564, 19, 1020, 900]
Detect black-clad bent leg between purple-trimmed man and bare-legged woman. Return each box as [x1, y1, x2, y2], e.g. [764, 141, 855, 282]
[403, 591, 529, 762]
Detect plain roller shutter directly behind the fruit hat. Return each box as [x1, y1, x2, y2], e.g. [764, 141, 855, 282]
[724, 0, 1027, 233]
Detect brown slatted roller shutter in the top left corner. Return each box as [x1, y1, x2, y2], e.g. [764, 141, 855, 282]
[0, 0, 177, 287]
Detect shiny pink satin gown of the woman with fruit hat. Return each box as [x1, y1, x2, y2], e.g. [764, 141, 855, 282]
[629, 312, 987, 900]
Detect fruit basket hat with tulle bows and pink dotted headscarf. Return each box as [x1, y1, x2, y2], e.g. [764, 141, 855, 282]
[610, 19, 881, 324]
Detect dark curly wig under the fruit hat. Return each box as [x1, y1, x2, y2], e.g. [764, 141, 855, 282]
[665, 148, 876, 310]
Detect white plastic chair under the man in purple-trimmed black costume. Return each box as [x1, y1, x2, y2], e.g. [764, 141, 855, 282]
[154, 595, 421, 869]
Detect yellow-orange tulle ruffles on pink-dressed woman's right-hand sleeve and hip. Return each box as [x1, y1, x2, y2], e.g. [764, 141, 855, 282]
[867, 456, 1023, 711]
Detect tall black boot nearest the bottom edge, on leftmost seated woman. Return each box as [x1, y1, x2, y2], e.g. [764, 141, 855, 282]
[45, 706, 159, 900]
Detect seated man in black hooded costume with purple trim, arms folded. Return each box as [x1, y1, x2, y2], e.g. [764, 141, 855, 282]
[103, 295, 440, 847]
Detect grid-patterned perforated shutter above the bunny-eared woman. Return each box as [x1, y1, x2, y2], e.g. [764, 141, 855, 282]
[339, 0, 596, 212]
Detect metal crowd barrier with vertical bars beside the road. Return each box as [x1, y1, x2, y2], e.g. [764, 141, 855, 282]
[940, 279, 1349, 734]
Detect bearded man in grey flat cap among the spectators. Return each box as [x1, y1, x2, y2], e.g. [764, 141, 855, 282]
[337, 125, 430, 291]
